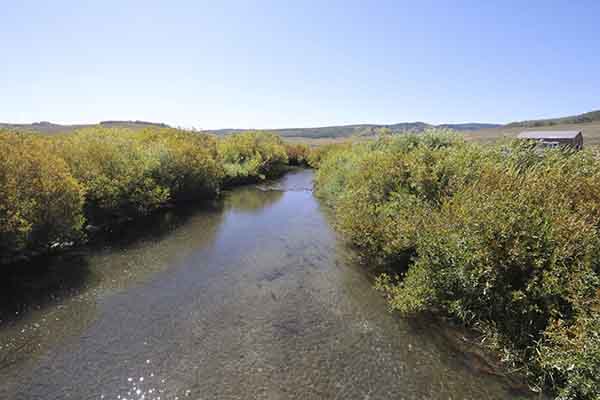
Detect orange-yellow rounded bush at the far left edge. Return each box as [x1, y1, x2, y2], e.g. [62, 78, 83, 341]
[0, 132, 84, 260]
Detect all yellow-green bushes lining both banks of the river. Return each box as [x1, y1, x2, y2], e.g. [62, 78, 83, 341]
[0, 127, 600, 399]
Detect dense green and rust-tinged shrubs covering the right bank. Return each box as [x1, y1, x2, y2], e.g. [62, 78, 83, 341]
[316, 132, 600, 399]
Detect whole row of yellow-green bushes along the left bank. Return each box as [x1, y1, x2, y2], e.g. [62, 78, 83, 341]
[0, 127, 290, 262]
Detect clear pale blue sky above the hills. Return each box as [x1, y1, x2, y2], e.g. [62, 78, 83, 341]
[0, 0, 600, 128]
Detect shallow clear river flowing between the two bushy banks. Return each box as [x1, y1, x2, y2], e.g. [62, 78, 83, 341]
[0, 170, 528, 400]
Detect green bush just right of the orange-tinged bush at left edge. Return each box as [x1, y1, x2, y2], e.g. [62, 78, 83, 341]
[56, 128, 170, 223]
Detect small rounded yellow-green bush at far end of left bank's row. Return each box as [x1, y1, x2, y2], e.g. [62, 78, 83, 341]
[217, 132, 288, 184]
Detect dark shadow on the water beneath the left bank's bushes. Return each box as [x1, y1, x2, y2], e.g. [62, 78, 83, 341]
[0, 201, 223, 328]
